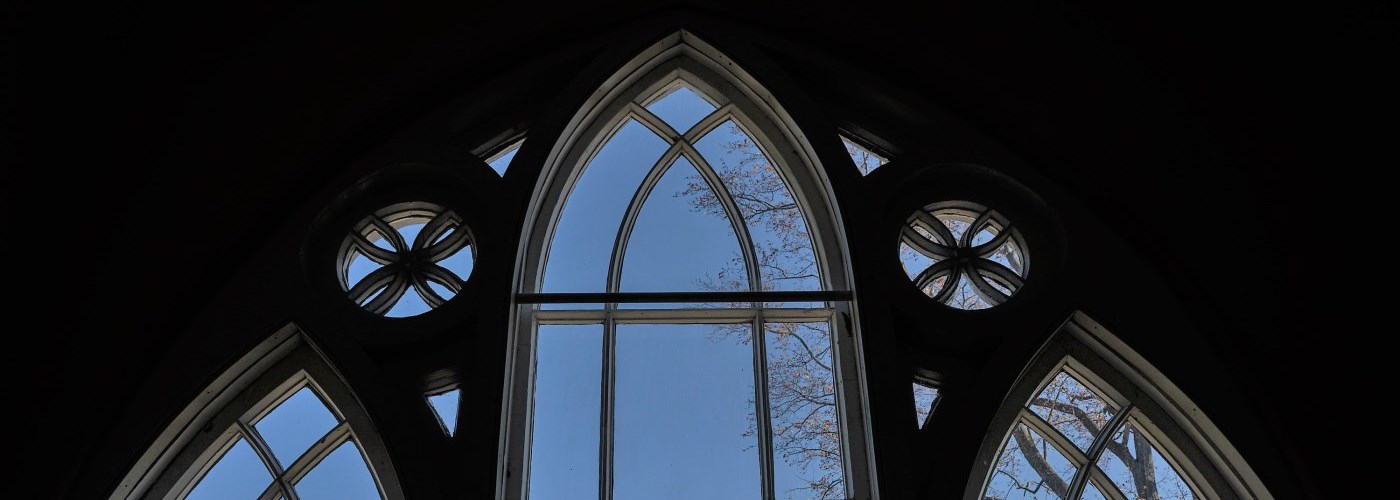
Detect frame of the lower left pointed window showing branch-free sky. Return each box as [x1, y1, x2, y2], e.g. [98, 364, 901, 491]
[109, 325, 405, 500]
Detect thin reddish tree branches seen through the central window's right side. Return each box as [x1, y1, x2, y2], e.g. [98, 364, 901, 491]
[673, 122, 846, 499]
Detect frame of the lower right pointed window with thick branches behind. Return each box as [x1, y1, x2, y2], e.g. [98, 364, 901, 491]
[963, 311, 1273, 500]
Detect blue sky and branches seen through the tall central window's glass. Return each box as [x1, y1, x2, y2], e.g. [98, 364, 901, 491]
[528, 79, 846, 500]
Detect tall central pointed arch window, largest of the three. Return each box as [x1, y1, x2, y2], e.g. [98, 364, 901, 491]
[500, 32, 871, 499]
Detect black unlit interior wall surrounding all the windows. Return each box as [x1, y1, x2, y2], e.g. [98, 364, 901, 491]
[13, 1, 1393, 499]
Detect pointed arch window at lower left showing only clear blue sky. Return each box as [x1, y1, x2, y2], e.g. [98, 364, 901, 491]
[111, 325, 403, 500]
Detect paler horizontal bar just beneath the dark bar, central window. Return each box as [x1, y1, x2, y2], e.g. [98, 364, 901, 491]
[533, 308, 832, 320]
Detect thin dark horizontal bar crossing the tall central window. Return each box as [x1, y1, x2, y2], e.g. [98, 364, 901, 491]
[515, 290, 851, 304]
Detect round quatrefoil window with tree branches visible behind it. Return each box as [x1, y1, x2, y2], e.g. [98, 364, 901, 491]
[899, 202, 1029, 310]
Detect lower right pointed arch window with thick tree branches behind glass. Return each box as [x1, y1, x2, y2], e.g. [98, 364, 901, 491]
[966, 312, 1271, 500]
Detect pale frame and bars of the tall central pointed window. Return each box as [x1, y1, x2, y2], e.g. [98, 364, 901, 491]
[496, 31, 878, 499]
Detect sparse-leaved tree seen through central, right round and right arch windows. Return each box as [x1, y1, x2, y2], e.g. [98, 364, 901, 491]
[675, 122, 1193, 500]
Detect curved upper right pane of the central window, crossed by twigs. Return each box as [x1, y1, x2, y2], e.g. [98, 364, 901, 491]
[696, 120, 820, 290]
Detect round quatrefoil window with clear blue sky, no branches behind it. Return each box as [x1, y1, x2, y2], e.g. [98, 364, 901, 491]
[337, 202, 476, 318]
